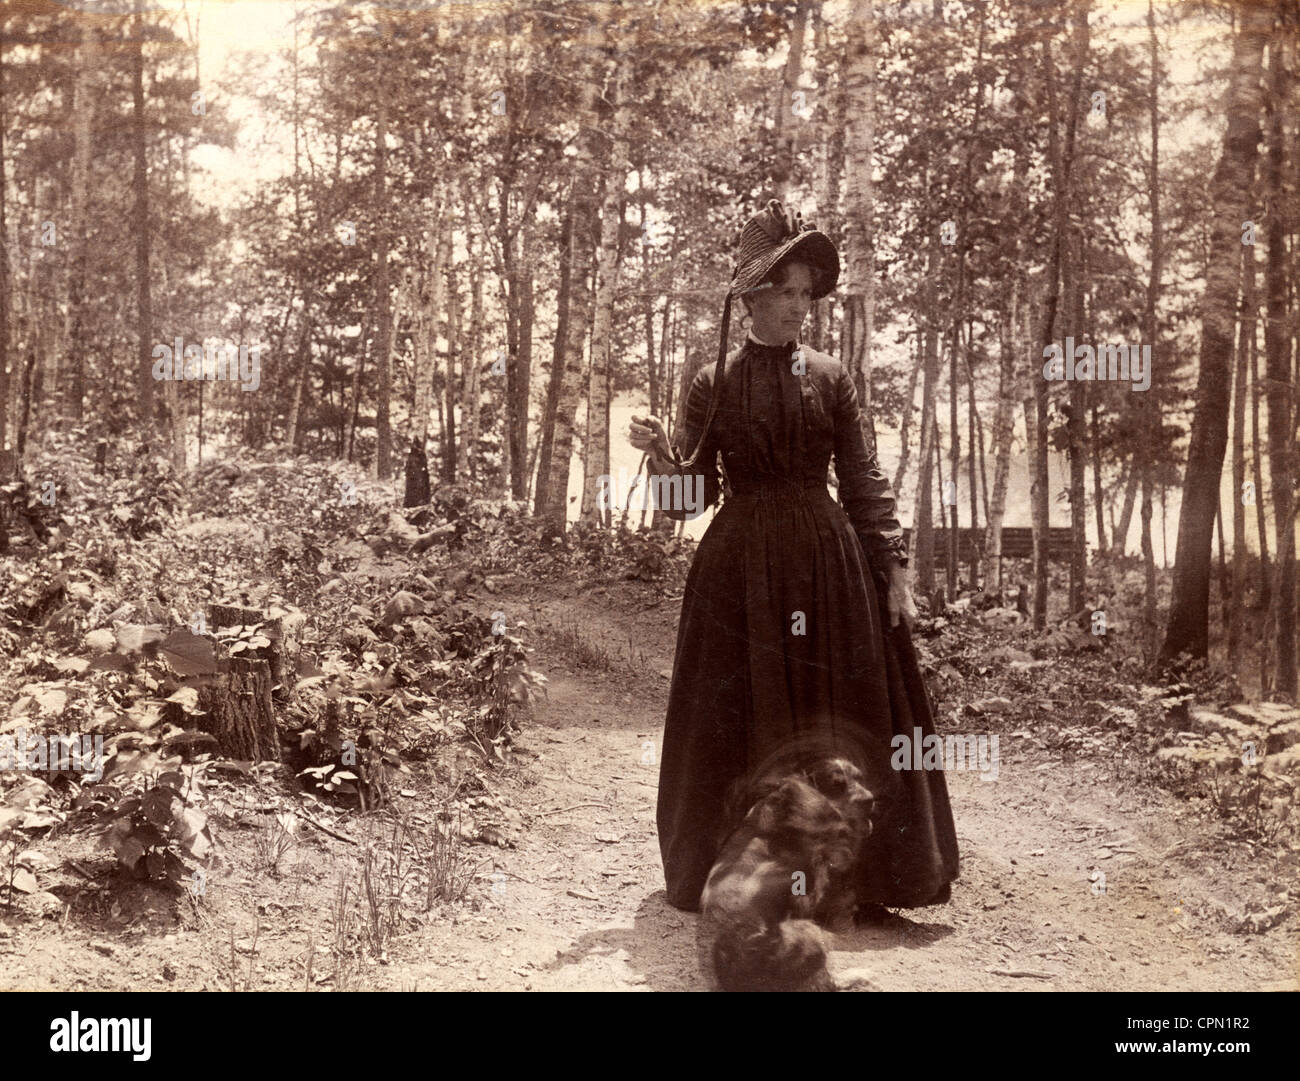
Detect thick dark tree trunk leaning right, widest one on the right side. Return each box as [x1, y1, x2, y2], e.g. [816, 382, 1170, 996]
[1160, 6, 1273, 665]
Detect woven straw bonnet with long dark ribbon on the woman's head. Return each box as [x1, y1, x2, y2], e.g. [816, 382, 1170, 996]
[677, 199, 840, 472]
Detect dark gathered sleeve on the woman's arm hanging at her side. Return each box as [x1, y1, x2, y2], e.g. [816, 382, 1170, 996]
[835, 368, 907, 577]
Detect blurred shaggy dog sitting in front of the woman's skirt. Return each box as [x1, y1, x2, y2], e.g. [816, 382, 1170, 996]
[698, 733, 874, 991]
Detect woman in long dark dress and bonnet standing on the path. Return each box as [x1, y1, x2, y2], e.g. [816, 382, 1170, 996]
[629, 200, 958, 916]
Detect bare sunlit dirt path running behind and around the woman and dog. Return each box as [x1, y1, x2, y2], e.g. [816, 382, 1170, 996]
[402, 579, 1300, 991]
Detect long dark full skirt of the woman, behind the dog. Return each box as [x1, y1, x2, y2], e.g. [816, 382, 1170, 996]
[657, 489, 958, 911]
